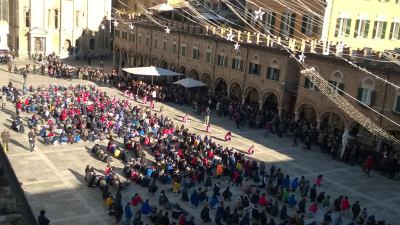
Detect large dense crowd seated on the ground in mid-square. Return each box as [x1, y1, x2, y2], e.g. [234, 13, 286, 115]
[0, 76, 385, 225]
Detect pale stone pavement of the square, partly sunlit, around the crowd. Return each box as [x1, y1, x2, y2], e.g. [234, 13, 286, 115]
[0, 60, 400, 225]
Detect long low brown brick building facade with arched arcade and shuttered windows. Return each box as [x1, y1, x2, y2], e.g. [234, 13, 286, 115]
[114, 20, 400, 148]
